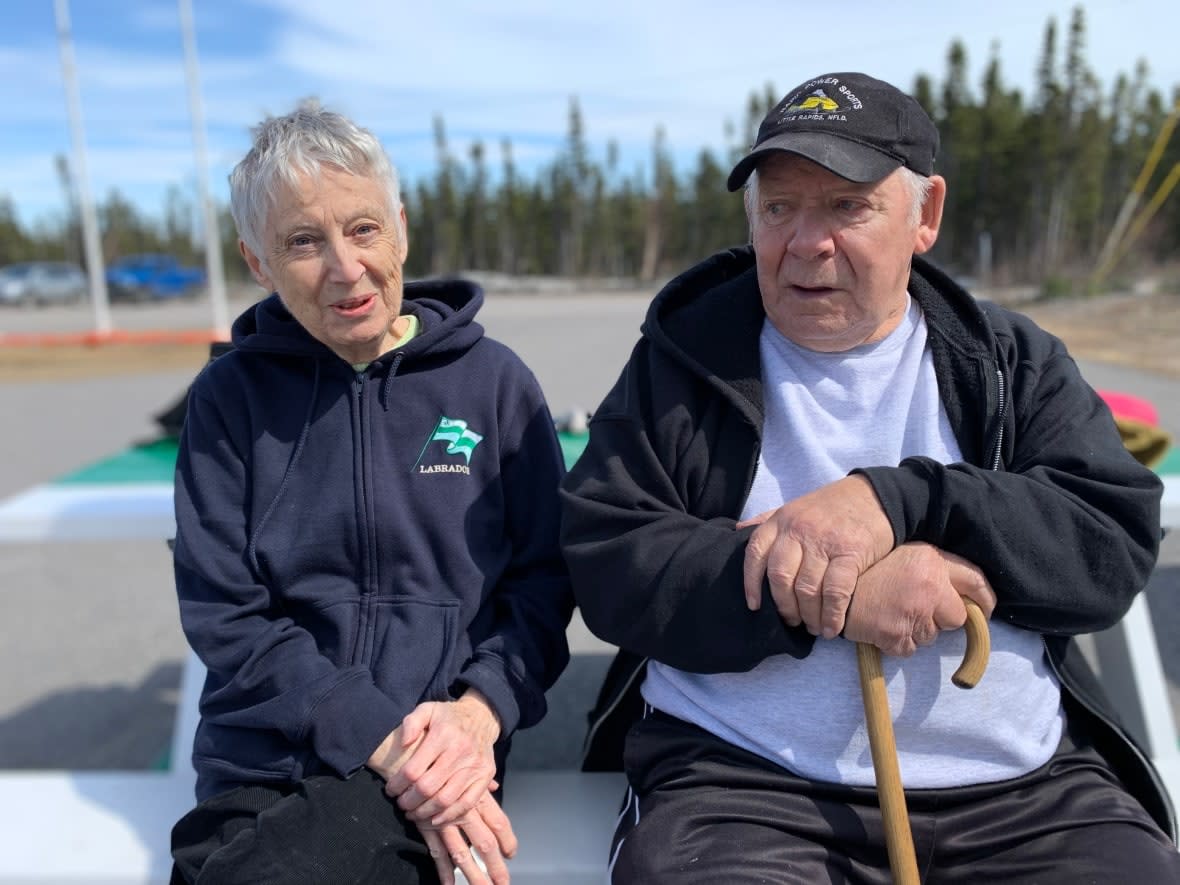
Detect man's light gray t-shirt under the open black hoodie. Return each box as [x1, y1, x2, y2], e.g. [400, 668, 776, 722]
[643, 300, 1062, 788]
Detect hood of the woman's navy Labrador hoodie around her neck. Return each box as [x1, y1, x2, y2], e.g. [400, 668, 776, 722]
[230, 280, 484, 361]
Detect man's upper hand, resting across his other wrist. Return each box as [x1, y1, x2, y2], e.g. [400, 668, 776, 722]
[738, 474, 893, 638]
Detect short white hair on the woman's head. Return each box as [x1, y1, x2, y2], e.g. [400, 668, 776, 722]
[229, 99, 405, 261]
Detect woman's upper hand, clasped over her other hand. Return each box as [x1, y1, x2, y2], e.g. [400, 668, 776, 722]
[385, 689, 500, 827]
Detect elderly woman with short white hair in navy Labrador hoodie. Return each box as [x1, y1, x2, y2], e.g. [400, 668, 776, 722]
[172, 105, 572, 885]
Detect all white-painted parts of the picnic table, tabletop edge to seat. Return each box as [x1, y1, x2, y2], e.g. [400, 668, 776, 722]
[0, 476, 1180, 885]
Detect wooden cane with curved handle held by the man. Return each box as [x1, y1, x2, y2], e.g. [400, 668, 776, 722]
[857, 599, 991, 885]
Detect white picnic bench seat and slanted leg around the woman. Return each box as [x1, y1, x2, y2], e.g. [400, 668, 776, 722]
[0, 654, 623, 885]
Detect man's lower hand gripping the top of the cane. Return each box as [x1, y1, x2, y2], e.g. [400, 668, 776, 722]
[844, 543, 996, 657]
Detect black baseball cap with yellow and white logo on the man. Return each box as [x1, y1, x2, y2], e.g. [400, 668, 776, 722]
[728, 73, 938, 191]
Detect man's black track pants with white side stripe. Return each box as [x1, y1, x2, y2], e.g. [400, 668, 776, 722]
[610, 712, 1180, 885]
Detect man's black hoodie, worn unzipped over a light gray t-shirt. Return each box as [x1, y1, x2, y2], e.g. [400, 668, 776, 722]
[562, 248, 1174, 834]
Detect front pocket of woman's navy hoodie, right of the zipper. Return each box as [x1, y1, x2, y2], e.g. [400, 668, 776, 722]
[356, 596, 459, 714]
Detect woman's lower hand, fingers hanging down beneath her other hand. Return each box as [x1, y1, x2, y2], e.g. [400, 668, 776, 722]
[418, 793, 517, 885]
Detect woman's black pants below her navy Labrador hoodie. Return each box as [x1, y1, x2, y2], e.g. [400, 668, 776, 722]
[171, 768, 439, 885]
